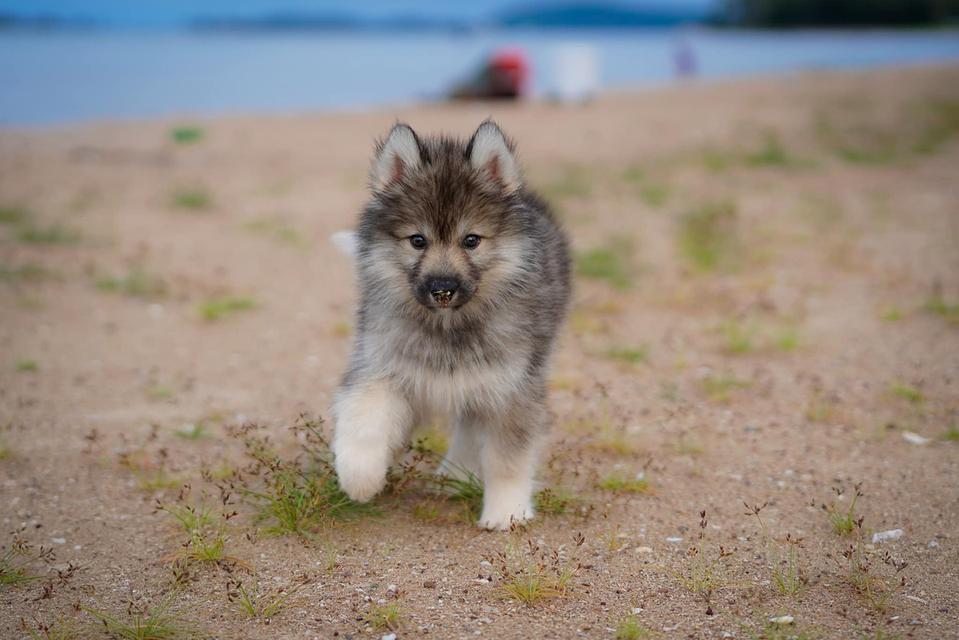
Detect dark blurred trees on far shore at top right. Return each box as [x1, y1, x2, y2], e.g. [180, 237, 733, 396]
[719, 0, 959, 28]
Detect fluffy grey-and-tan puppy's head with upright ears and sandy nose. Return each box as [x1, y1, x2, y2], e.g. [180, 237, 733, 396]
[359, 122, 528, 315]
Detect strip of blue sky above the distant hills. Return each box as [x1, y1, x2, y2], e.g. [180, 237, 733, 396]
[0, 0, 715, 26]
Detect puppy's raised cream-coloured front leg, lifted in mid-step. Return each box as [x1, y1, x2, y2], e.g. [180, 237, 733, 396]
[333, 380, 413, 502]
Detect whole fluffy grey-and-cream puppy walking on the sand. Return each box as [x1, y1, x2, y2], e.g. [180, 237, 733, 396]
[333, 120, 570, 529]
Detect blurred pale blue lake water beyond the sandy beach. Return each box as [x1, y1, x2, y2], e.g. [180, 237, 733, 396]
[0, 30, 959, 125]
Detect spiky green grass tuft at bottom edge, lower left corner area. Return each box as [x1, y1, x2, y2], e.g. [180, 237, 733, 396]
[82, 592, 202, 640]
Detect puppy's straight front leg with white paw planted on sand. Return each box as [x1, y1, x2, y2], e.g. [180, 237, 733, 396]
[479, 404, 546, 530]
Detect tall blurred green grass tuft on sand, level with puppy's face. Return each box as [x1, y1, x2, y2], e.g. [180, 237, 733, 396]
[678, 200, 739, 273]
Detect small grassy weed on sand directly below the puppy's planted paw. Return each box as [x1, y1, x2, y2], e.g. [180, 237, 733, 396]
[490, 534, 585, 607]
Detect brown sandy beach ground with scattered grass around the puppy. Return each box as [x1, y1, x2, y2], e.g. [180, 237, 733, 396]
[0, 61, 959, 638]
